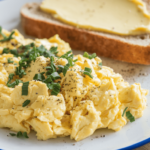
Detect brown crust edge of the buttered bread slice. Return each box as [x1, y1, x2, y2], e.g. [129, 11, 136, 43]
[21, 4, 150, 65]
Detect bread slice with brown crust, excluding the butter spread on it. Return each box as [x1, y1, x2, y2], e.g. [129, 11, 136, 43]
[21, 0, 150, 65]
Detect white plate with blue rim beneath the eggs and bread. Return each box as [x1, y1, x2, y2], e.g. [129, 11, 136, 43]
[0, 0, 150, 150]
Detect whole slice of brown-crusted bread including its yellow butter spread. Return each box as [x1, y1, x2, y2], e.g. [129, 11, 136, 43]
[21, 0, 150, 65]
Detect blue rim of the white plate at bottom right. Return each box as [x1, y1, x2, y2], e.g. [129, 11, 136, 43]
[0, 138, 150, 150]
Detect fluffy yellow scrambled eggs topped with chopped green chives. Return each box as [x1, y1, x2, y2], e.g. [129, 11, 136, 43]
[0, 28, 148, 141]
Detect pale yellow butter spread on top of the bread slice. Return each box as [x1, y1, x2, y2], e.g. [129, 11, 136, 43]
[40, 0, 150, 35]
